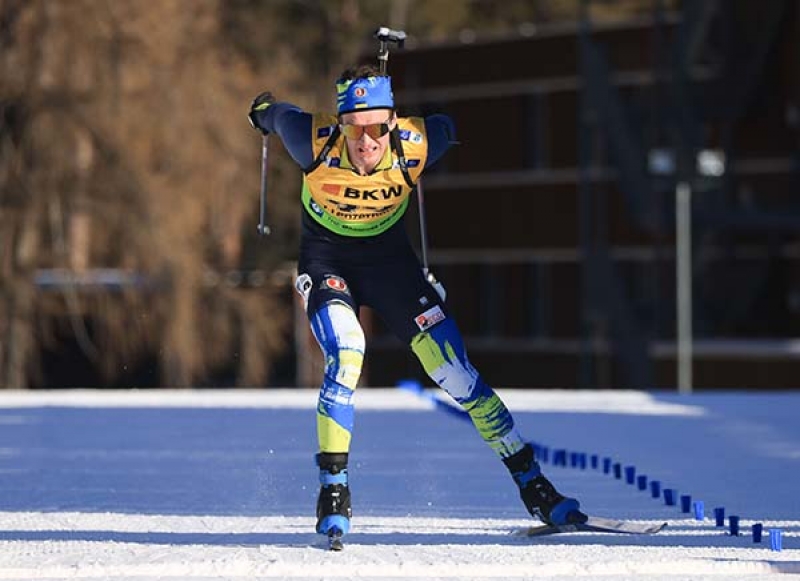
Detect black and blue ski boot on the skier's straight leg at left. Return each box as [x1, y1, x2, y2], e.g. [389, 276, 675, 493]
[317, 452, 353, 538]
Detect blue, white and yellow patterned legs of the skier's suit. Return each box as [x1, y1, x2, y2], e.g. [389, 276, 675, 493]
[297, 266, 524, 458]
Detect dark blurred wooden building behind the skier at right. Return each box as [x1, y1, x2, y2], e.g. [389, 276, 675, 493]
[360, 0, 800, 389]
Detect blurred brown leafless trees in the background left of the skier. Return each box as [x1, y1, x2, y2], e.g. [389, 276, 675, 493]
[0, 0, 286, 387]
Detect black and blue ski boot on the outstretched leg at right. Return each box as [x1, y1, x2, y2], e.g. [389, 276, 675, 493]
[503, 444, 587, 526]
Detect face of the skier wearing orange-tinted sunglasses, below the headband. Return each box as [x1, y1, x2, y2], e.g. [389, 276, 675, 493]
[340, 109, 396, 172]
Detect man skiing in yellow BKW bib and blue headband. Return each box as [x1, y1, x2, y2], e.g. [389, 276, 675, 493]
[249, 65, 586, 537]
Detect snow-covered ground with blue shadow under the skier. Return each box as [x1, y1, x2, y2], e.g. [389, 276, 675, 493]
[0, 389, 800, 581]
